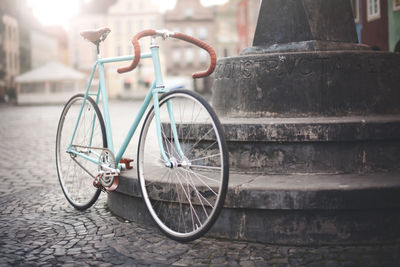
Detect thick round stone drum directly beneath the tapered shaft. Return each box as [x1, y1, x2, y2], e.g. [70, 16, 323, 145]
[212, 51, 400, 117]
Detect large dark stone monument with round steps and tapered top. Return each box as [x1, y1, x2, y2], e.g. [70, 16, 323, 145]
[208, 0, 400, 244]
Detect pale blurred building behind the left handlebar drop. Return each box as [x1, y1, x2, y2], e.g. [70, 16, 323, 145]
[106, 0, 164, 98]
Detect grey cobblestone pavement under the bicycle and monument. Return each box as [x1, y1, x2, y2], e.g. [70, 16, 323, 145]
[0, 102, 400, 266]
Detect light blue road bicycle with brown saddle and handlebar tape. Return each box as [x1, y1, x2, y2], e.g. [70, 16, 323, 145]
[56, 28, 229, 242]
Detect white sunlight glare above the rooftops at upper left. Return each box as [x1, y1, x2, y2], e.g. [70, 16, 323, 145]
[28, 0, 80, 28]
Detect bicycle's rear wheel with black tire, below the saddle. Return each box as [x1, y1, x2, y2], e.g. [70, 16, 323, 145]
[56, 94, 107, 210]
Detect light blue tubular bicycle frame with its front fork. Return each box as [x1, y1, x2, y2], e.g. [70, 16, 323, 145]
[67, 39, 184, 168]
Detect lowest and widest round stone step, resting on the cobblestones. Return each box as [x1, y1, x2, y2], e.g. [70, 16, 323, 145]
[108, 170, 400, 245]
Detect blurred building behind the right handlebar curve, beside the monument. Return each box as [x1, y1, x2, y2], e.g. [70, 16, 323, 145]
[164, 0, 218, 94]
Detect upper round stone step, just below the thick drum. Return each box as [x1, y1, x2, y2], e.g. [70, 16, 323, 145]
[173, 114, 400, 175]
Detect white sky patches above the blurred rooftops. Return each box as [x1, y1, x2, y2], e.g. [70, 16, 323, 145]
[28, 0, 229, 28]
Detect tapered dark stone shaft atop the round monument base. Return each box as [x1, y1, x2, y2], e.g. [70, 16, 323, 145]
[253, 0, 357, 49]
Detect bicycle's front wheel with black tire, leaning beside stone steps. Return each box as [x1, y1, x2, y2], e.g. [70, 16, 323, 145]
[137, 90, 229, 242]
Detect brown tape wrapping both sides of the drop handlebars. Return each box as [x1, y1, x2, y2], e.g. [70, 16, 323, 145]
[117, 30, 217, 79]
